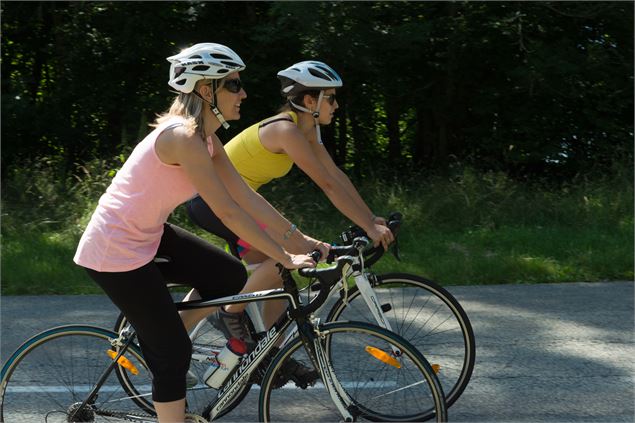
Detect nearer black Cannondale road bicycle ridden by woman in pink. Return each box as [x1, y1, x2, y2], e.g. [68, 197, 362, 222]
[0, 256, 447, 423]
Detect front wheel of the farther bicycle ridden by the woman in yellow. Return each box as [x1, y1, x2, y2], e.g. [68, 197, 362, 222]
[326, 273, 476, 407]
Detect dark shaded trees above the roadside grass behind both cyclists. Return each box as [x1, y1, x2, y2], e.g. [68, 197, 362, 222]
[1, 1, 633, 178]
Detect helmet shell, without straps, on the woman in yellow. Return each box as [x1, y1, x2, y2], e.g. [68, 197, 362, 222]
[278, 60, 343, 97]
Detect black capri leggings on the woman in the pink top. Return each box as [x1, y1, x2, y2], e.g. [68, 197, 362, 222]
[86, 224, 247, 402]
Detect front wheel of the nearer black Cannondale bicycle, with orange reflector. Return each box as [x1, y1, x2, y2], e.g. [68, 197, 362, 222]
[258, 322, 447, 422]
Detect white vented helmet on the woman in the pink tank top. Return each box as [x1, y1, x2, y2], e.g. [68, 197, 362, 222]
[167, 43, 246, 93]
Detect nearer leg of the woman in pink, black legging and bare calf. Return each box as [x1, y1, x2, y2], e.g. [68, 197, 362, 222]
[88, 263, 192, 423]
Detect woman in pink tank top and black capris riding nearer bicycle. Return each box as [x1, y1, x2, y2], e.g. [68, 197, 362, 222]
[74, 43, 328, 422]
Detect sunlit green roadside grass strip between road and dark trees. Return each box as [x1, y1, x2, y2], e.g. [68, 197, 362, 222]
[1, 158, 634, 295]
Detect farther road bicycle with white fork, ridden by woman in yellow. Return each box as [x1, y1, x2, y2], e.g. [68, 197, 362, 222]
[115, 213, 476, 414]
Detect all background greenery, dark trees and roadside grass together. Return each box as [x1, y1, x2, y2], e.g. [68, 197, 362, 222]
[0, 1, 634, 293]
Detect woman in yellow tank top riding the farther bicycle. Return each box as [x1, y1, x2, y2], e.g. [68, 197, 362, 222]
[187, 61, 394, 354]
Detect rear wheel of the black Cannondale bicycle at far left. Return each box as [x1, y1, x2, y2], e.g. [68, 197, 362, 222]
[0, 325, 152, 423]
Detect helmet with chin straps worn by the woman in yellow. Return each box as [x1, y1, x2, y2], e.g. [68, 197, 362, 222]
[278, 60, 344, 144]
